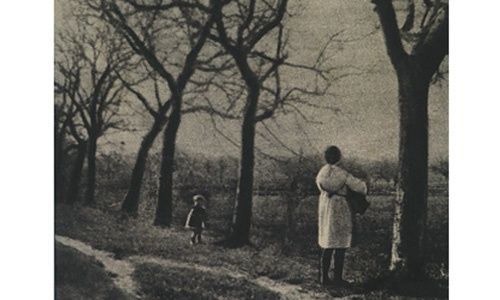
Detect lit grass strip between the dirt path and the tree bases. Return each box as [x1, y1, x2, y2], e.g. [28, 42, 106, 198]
[56, 205, 316, 282]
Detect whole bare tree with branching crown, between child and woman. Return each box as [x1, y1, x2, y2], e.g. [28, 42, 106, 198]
[201, 0, 338, 246]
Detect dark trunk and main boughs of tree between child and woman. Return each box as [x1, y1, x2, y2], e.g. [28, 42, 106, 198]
[211, 0, 288, 247]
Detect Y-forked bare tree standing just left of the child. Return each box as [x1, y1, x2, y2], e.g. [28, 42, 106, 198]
[95, 0, 217, 226]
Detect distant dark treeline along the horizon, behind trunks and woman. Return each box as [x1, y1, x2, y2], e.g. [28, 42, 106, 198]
[59, 151, 447, 196]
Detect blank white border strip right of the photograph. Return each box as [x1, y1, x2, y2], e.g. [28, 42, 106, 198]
[450, 1, 500, 299]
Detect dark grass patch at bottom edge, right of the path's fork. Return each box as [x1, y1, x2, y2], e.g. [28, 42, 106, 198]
[133, 264, 279, 300]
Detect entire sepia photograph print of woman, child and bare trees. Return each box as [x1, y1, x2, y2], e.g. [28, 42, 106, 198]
[53, 0, 449, 300]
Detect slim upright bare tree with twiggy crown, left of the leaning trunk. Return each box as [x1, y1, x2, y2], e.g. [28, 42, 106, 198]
[55, 20, 133, 205]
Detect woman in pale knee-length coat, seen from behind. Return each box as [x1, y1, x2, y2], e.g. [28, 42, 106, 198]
[316, 146, 367, 286]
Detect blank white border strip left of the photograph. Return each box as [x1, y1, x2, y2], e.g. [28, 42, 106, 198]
[0, 0, 54, 299]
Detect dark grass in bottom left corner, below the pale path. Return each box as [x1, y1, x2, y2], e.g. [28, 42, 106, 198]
[55, 244, 131, 300]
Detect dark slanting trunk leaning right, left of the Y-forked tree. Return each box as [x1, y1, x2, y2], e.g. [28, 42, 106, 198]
[121, 116, 165, 216]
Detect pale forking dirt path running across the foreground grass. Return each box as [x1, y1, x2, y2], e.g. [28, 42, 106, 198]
[55, 235, 352, 300]
